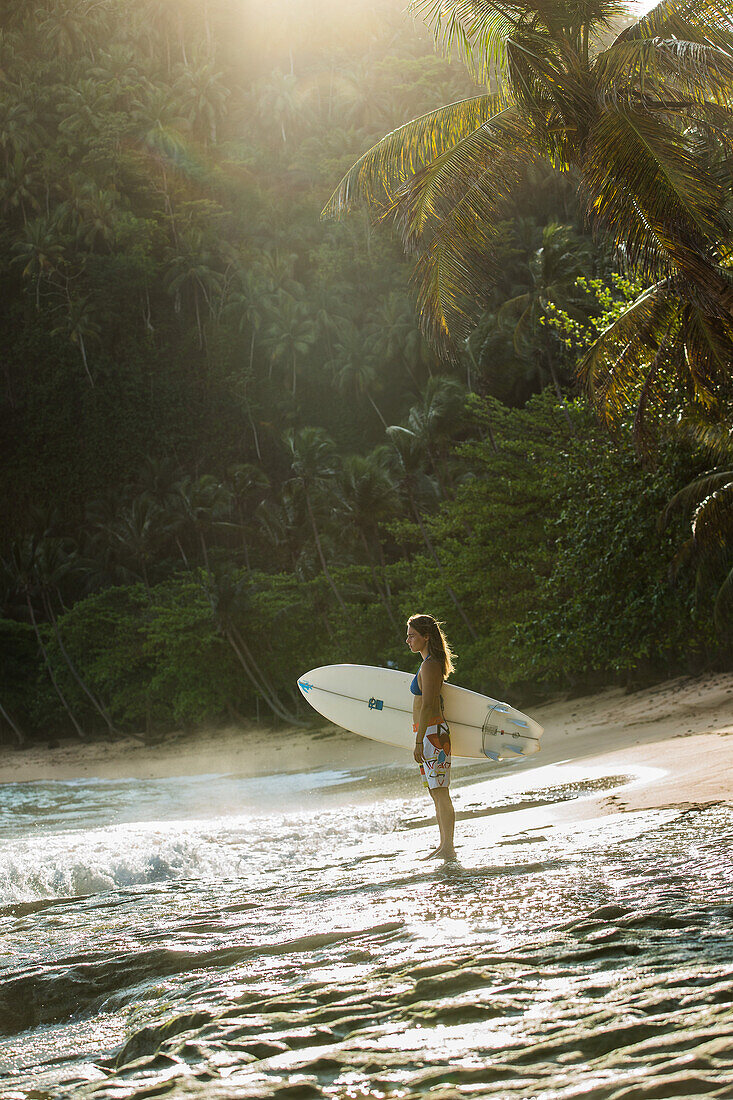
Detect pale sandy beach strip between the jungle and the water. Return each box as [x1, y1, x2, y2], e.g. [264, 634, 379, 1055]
[0, 673, 733, 821]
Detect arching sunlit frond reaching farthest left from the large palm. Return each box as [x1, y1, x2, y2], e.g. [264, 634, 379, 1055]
[322, 95, 506, 217]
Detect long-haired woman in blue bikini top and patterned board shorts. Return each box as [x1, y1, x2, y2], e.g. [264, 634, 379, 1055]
[406, 615, 456, 859]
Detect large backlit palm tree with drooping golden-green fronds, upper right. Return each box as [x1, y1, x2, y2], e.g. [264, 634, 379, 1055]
[325, 0, 733, 409]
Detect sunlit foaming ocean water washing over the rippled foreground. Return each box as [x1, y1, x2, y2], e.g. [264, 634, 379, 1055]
[0, 752, 733, 1100]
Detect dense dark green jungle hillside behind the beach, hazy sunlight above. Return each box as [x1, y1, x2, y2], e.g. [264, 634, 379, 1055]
[0, 0, 731, 744]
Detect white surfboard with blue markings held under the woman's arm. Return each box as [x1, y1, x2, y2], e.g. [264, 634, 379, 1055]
[298, 664, 543, 760]
